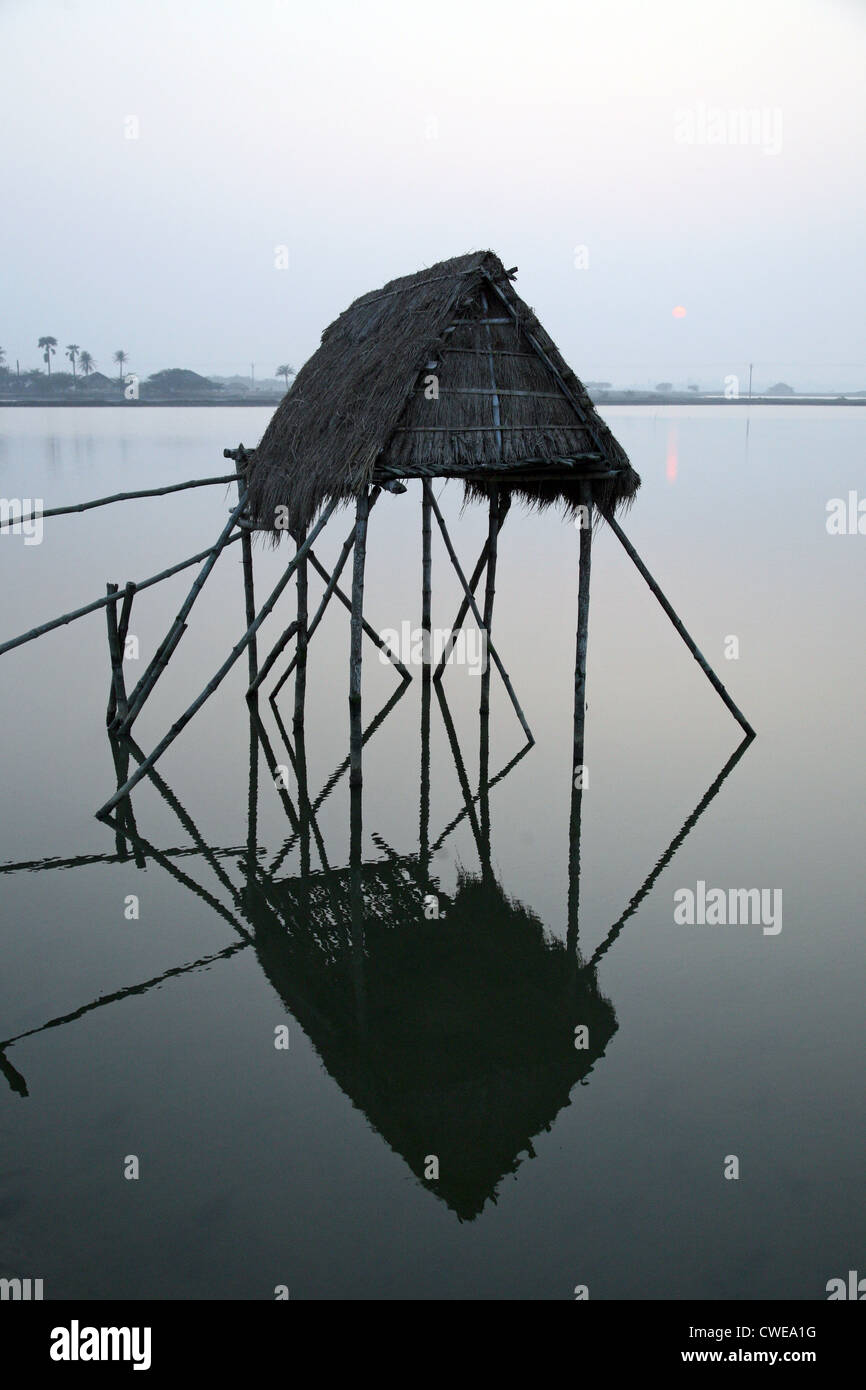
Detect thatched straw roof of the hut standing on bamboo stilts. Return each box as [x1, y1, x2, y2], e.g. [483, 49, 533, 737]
[250, 252, 641, 531]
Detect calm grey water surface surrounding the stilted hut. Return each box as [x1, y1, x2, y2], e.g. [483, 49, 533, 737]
[0, 407, 866, 1300]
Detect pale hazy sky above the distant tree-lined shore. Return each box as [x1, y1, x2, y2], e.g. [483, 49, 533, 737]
[0, 0, 866, 389]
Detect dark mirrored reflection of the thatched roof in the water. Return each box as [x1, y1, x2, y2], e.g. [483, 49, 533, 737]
[247, 859, 616, 1219]
